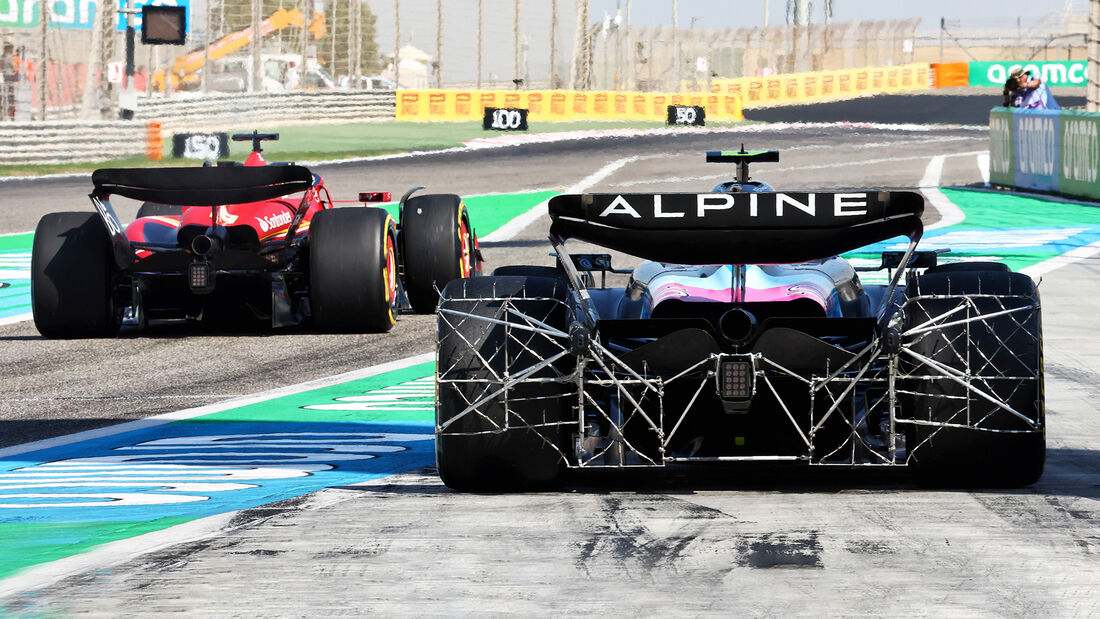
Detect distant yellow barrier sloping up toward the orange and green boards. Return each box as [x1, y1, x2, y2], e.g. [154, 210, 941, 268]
[711, 63, 930, 108]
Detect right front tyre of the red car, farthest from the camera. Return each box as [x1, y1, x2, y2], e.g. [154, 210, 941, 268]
[400, 194, 476, 313]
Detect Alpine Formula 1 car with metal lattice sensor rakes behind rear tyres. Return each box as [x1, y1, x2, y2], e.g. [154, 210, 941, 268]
[436, 148, 1045, 490]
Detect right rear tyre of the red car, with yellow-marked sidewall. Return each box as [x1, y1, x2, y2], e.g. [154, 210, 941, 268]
[309, 208, 398, 333]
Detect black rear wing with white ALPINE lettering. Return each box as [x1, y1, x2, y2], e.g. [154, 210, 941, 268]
[549, 191, 924, 264]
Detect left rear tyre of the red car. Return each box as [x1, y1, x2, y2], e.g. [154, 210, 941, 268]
[31, 212, 122, 339]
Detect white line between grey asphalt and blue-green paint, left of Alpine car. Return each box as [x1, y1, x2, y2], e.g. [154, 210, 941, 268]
[0, 353, 436, 458]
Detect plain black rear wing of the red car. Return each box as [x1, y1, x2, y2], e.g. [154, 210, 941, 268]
[91, 164, 314, 207]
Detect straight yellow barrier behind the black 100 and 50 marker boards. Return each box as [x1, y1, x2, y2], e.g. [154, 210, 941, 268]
[395, 90, 745, 122]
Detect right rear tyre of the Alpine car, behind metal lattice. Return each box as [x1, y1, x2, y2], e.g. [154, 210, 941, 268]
[901, 265, 1046, 487]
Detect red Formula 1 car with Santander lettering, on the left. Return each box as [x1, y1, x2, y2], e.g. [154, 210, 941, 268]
[31, 132, 482, 338]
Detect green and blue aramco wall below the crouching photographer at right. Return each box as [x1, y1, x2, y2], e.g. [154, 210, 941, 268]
[989, 108, 1100, 200]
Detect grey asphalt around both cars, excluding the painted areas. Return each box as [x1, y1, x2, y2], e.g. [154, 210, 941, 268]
[0, 97, 1100, 617]
